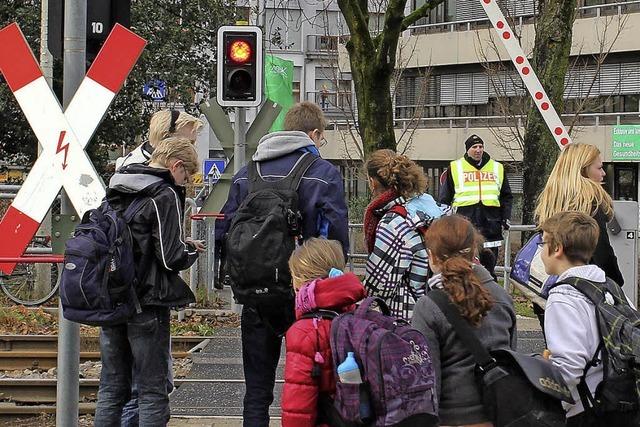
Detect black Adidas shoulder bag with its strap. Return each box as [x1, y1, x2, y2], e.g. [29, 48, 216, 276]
[427, 289, 574, 427]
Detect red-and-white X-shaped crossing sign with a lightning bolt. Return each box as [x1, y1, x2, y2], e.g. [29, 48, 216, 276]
[0, 24, 146, 274]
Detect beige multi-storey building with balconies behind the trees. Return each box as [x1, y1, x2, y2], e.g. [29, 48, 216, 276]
[251, 0, 640, 200]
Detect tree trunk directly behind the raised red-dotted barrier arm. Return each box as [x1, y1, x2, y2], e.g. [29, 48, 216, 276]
[522, 0, 577, 224]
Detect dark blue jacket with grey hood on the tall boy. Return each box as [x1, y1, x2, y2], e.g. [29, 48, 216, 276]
[215, 132, 349, 256]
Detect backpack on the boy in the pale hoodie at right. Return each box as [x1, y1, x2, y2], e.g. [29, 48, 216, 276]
[553, 277, 640, 427]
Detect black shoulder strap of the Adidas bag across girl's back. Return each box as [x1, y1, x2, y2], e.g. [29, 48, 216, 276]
[427, 289, 496, 373]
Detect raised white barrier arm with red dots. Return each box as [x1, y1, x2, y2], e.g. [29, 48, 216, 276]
[478, 0, 572, 150]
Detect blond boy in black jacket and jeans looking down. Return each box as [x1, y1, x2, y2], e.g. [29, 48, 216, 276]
[95, 138, 204, 426]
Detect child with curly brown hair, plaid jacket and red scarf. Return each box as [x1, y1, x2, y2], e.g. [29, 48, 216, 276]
[364, 150, 442, 320]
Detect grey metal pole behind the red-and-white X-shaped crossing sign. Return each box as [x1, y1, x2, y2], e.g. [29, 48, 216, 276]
[56, 0, 87, 427]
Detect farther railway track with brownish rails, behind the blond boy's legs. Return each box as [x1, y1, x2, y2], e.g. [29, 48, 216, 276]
[0, 335, 207, 371]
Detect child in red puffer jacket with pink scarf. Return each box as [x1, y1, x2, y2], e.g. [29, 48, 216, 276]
[281, 238, 366, 427]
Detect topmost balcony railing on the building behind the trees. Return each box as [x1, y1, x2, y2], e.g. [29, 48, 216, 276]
[409, 0, 640, 34]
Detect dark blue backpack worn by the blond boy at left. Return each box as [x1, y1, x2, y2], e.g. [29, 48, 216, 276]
[60, 197, 147, 326]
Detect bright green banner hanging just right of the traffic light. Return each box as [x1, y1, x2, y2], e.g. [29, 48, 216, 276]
[264, 55, 293, 132]
